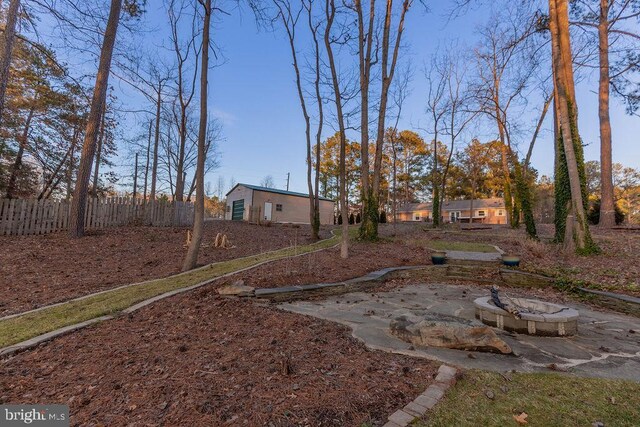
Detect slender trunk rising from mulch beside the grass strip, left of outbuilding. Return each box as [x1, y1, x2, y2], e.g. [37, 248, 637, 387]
[182, 0, 211, 271]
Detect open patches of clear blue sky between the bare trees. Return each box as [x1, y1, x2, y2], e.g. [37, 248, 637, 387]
[42, 2, 640, 197]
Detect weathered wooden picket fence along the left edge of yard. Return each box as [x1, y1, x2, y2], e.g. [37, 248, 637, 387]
[0, 197, 193, 236]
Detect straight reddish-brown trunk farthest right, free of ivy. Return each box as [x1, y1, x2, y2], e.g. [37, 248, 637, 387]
[598, 0, 616, 228]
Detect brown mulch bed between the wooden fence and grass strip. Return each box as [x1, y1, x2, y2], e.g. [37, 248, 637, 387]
[0, 221, 329, 316]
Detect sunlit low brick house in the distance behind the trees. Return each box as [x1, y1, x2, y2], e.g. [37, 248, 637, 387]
[397, 198, 507, 224]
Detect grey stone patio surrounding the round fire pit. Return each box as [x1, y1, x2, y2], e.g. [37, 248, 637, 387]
[279, 284, 640, 381]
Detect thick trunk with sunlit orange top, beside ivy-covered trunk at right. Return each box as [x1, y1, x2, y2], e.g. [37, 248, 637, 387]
[549, 0, 597, 253]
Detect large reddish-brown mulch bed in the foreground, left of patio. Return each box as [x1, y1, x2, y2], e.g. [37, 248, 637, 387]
[0, 286, 437, 426]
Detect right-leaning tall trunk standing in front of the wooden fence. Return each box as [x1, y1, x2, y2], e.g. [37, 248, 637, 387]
[69, 0, 122, 237]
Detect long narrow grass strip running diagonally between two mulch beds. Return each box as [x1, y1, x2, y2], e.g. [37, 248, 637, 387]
[0, 230, 344, 348]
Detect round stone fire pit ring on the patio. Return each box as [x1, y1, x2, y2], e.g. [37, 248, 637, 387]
[473, 296, 579, 337]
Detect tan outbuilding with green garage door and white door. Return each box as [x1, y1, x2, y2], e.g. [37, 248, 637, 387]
[224, 184, 335, 225]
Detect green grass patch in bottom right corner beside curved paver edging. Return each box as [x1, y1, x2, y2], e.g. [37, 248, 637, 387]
[415, 370, 640, 427]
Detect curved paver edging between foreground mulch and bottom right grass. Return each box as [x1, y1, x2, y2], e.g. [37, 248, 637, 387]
[383, 365, 458, 427]
